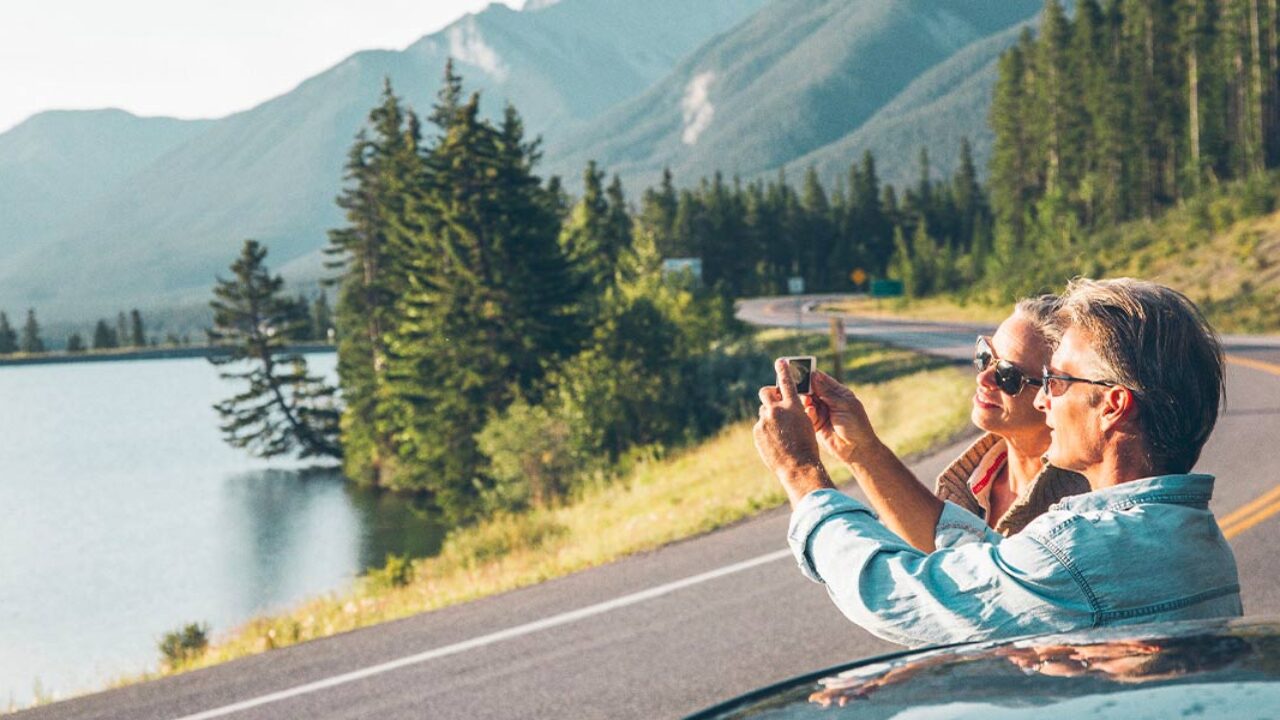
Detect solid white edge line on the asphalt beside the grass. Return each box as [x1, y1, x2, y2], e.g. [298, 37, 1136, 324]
[177, 550, 791, 720]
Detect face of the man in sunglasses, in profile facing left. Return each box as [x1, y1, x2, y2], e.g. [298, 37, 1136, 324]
[1036, 327, 1102, 477]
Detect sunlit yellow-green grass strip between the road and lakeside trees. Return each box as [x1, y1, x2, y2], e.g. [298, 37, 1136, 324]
[118, 325, 973, 684]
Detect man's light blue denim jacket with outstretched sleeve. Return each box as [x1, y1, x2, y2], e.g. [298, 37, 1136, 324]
[788, 474, 1242, 646]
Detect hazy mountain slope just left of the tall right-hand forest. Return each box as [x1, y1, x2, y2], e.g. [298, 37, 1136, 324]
[788, 23, 1025, 187]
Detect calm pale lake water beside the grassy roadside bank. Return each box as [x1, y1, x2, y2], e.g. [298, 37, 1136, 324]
[0, 355, 440, 710]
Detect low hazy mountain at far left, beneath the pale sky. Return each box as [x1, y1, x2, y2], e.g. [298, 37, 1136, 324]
[0, 110, 210, 258]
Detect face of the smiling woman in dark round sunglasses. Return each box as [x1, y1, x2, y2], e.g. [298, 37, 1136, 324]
[970, 313, 1052, 438]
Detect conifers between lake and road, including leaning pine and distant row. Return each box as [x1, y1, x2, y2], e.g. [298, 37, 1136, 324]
[215, 64, 1008, 520]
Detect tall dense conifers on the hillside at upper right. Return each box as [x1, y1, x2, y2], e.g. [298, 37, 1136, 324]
[957, 0, 1280, 300]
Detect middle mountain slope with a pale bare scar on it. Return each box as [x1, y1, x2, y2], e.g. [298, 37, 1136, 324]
[548, 0, 1041, 186]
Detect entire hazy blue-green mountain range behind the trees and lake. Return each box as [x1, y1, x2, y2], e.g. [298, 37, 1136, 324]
[0, 0, 1041, 322]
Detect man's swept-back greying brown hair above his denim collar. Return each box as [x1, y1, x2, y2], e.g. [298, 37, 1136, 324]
[1059, 278, 1226, 473]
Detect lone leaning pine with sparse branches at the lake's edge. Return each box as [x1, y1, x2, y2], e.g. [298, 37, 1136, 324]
[209, 240, 342, 457]
